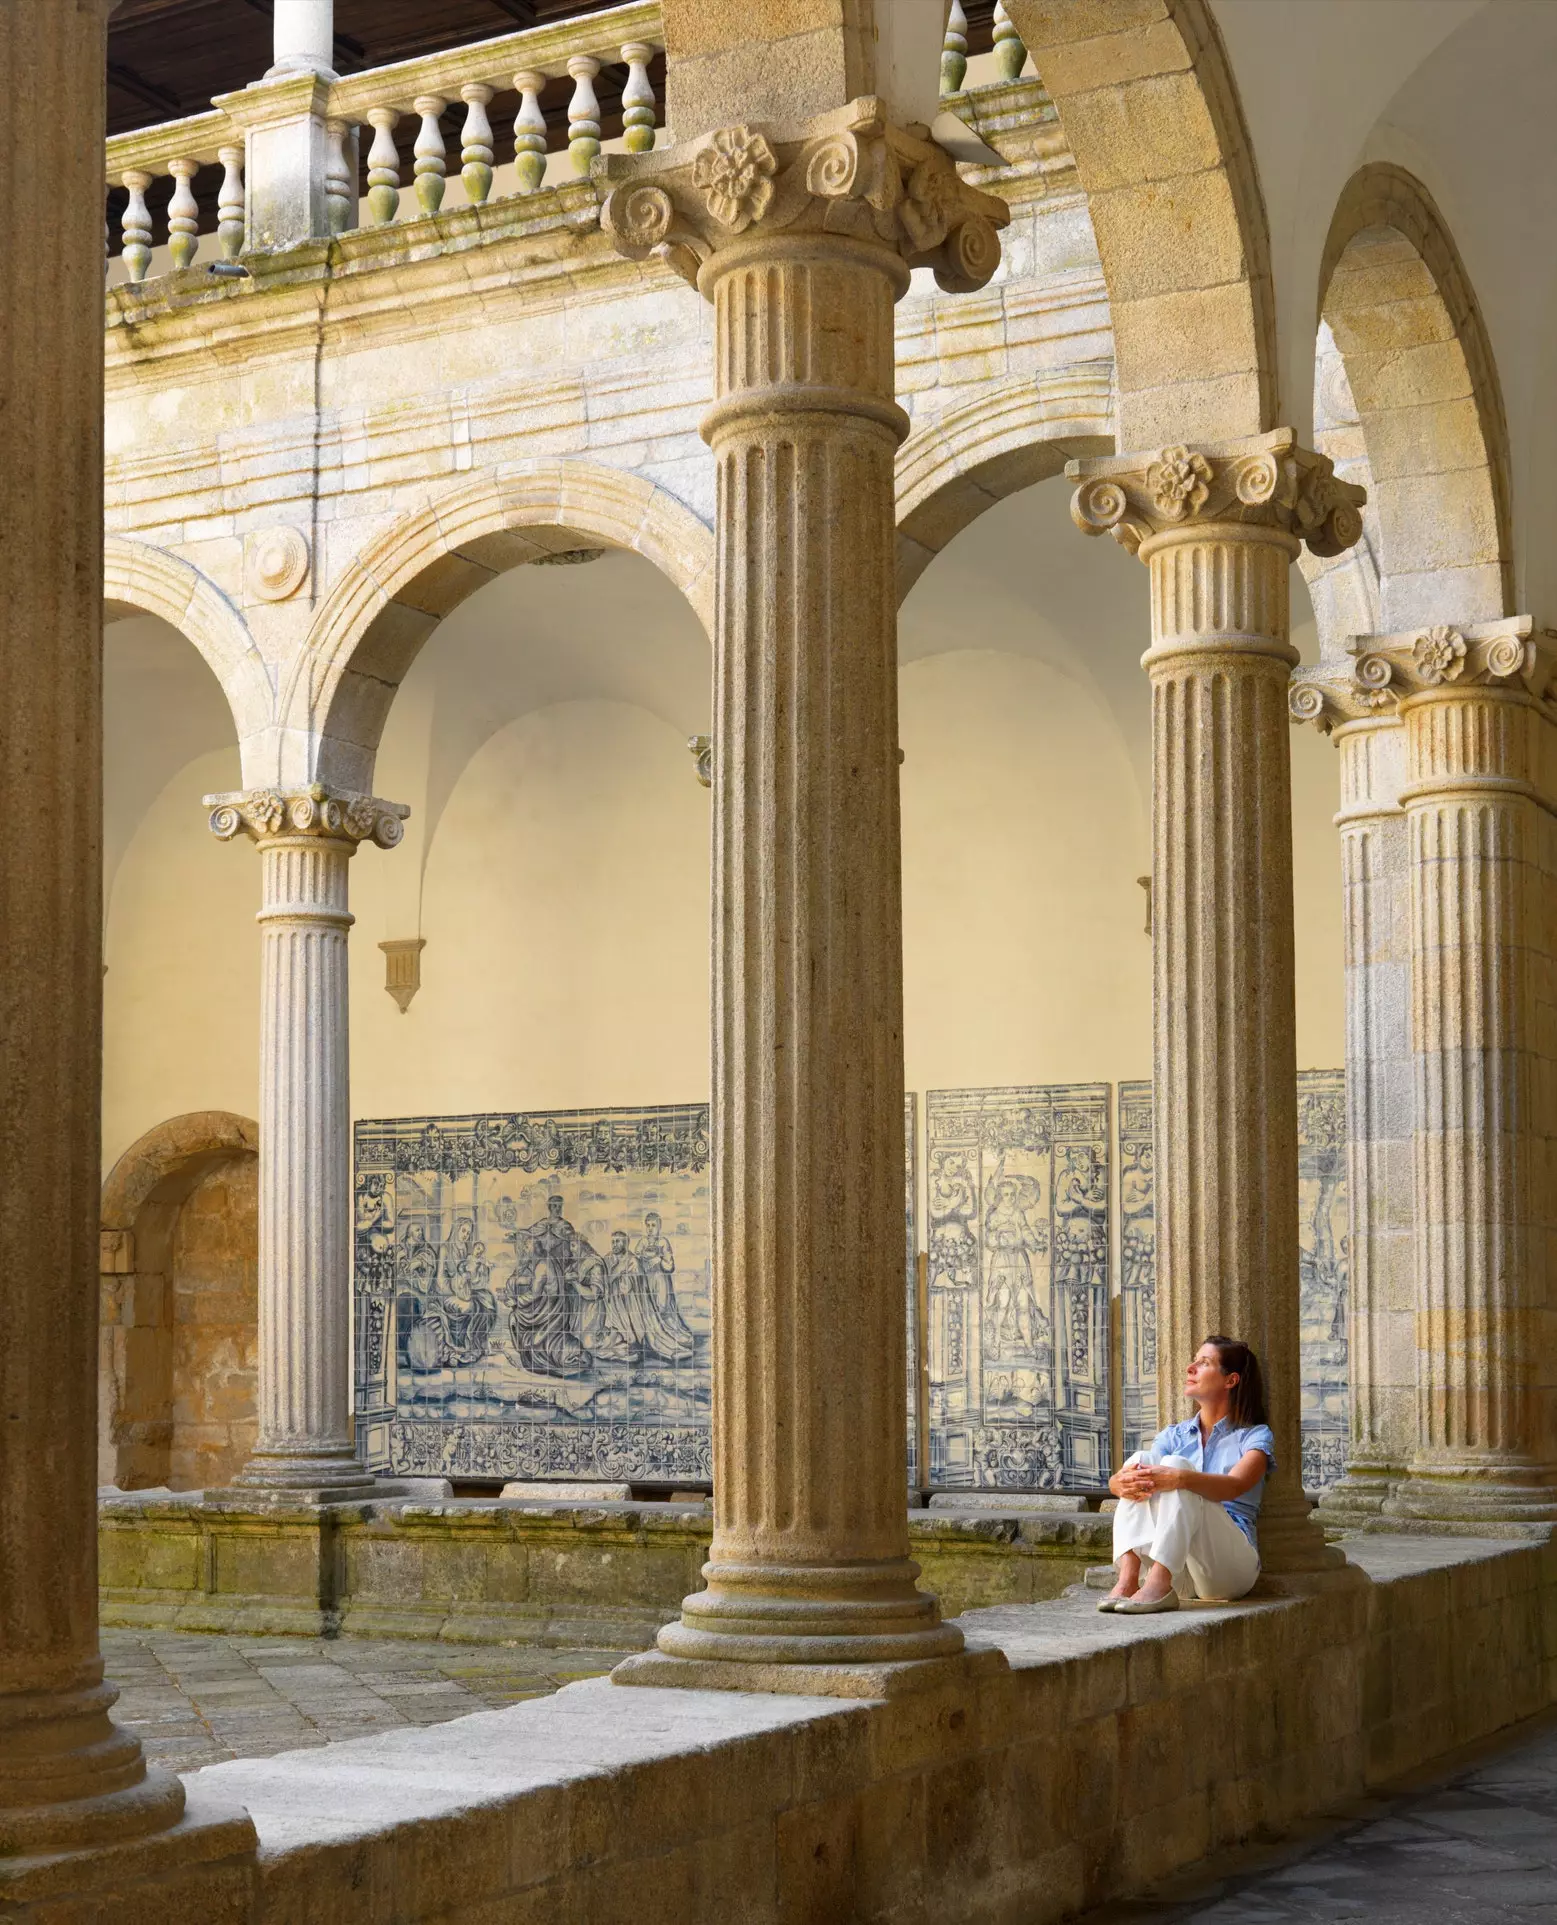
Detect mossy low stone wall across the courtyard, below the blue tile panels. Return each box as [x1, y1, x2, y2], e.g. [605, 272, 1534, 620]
[98, 1492, 1110, 1650]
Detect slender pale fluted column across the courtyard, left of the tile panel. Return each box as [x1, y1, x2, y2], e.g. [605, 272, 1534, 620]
[206, 785, 408, 1502]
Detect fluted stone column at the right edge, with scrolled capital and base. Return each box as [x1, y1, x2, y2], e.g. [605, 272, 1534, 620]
[1357, 616, 1557, 1528]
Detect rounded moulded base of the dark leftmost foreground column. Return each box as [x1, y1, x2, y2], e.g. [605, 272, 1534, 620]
[0, 1659, 185, 1863]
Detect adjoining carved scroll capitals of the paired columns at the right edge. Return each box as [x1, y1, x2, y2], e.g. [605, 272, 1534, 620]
[1288, 614, 1557, 735]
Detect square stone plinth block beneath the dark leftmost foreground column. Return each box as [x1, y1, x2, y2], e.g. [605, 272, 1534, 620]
[0, 1773, 258, 1925]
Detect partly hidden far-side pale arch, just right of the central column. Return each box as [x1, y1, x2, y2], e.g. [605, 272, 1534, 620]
[897, 364, 1114, 604]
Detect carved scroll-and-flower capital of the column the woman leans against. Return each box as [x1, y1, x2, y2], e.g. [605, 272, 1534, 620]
[1064, 427, 1368, 560]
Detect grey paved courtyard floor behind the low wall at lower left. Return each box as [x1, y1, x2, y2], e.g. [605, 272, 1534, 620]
[102, 1627, 625, 1771]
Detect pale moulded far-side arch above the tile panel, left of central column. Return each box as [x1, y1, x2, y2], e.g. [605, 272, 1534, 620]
[283, 460, 714, 789]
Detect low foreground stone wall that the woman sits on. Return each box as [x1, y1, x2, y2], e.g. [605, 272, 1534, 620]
[176, 1538, 1557, 1925]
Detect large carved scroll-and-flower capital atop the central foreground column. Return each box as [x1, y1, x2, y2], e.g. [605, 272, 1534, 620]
[595, 96, 1010, 293]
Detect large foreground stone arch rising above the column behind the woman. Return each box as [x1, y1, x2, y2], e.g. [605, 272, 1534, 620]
[1007, 0, 1280, 450]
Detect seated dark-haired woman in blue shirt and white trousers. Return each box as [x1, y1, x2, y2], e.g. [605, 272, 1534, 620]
[1097, 1336, 1276, 1615]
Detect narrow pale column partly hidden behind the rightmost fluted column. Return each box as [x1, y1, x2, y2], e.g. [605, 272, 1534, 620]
[1289, 662, 1417, 1527]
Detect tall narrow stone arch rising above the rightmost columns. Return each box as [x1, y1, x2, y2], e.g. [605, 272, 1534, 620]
[1318, 162, 1513, 629]
